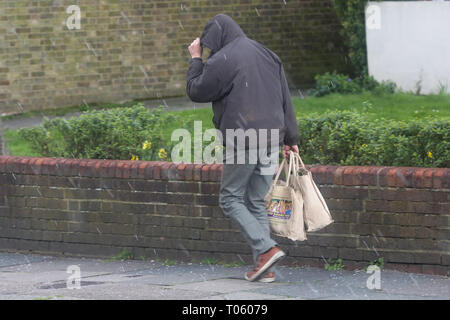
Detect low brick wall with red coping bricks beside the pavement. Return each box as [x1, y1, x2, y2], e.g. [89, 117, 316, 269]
[0, 156, 450, 275]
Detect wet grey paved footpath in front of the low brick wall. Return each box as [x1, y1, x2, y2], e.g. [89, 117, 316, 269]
[0, 252, 450, 300]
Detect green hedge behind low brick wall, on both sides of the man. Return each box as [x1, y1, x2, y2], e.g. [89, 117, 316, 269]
[19, 105, 450, 168]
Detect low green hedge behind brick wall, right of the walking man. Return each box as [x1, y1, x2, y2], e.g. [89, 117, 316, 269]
[297, 111, 450, 168]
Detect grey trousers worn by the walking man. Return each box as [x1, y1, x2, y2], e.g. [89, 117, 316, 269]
[219, 150, 279, 271]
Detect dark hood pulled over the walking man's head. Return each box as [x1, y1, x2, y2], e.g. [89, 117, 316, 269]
[200, 14, 246, 56]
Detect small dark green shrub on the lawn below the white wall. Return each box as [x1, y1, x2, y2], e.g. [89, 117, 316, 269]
[309, 72, 395, 97]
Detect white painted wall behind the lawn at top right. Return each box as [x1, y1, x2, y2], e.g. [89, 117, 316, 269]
[366, 1, 450, 93]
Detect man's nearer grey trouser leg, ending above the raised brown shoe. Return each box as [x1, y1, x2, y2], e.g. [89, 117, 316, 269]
[219, 164, 276, 256]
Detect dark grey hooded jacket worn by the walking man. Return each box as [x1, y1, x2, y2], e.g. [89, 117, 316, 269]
[186, 14, 298, 149]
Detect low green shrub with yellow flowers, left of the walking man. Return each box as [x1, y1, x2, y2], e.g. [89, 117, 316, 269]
[19, 104, 180, 160]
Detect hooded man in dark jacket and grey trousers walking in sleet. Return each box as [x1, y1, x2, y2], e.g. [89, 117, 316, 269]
[186, 14, 298, 282]
